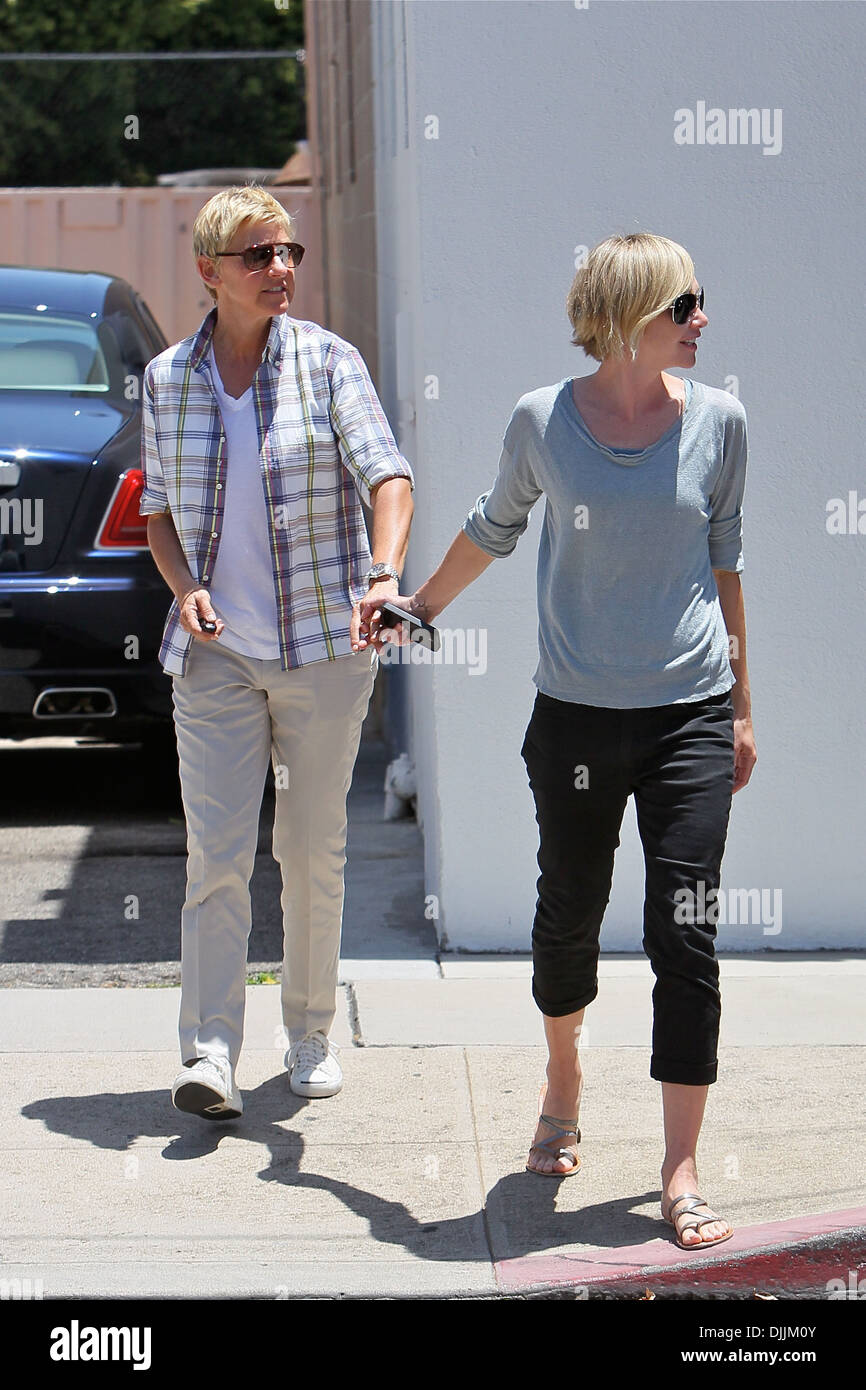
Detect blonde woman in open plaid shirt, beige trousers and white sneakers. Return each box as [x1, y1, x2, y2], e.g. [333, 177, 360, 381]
[140, 188, 414, 1120]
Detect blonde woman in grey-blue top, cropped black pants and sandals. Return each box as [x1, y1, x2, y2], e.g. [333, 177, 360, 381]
[359, 232, 756, 1250]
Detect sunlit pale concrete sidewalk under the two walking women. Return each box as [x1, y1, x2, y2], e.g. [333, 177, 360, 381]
[0, 954, 866, 1298]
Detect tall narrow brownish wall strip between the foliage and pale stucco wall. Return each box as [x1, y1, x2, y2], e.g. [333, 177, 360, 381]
[304, 0, 378, 382]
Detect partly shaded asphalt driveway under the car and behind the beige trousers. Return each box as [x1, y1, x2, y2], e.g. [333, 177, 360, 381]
[0, 739, 435, 988]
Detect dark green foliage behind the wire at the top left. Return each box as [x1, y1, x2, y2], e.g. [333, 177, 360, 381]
[0, 0, 306, 185]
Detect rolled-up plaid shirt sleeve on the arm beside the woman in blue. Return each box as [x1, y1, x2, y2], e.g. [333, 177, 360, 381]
[331, 348, 414, 505]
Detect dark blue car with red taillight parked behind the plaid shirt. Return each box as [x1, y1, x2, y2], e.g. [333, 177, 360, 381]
[0, 265, 171, 742]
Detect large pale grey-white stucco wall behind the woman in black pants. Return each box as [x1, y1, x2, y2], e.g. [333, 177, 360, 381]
[374, 0, 866, 951]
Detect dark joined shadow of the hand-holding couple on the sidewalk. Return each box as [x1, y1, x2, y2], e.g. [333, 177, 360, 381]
[21, 1073, 667, 1262]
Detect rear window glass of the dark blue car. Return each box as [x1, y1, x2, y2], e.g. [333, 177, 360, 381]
[0, 309, 110, 392]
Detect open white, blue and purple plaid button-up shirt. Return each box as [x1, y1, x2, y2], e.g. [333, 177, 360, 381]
[139, 307, 414, 676]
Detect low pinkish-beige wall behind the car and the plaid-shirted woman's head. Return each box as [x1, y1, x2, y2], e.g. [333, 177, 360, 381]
[0, 188, 324, 342]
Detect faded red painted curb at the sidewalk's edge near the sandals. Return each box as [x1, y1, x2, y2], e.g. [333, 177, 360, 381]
[493, 1207, 866, 1291]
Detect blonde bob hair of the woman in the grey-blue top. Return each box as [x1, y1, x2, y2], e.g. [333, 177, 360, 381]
[566, 232, 695, 361]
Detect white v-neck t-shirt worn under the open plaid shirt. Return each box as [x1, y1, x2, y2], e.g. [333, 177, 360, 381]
[209, 352, 279, 662]
